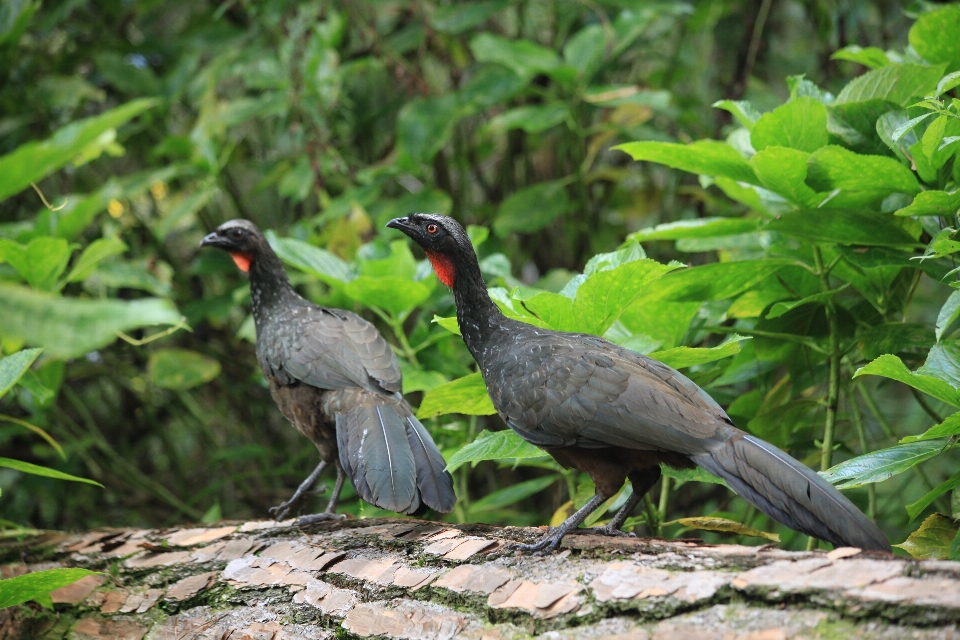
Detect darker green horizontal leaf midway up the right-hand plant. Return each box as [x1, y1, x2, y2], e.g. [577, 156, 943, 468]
[767, 207, 916, 247]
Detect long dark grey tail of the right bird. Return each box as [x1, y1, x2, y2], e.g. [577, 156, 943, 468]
[692, 430, 890, 551]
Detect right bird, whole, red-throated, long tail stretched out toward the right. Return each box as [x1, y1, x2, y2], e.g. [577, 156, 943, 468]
[387, 213, 890, 553]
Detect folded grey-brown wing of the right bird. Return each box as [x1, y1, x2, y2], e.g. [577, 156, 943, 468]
[488, 334, 727, 455]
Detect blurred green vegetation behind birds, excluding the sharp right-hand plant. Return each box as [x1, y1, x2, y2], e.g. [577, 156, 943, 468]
[0, 0, 960, 547]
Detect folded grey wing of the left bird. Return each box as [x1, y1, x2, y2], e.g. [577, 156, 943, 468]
[257, 305, 401, 394]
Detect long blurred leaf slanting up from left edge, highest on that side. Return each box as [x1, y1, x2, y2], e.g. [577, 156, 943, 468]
[0, 99, 156, 201]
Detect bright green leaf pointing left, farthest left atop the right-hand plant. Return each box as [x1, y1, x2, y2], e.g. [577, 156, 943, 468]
[613, 140, 762, 186]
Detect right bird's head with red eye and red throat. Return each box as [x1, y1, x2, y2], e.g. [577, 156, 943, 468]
[387, 213, 476, 287]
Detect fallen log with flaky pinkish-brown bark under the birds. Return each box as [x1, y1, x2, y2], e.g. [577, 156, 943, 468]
[0, 519, 960, 640]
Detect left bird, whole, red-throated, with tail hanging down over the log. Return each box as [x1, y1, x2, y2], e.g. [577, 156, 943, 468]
[200, 220, 457, 525]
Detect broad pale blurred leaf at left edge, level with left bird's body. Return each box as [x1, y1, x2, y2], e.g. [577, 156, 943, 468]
[0, 285, 181, 358]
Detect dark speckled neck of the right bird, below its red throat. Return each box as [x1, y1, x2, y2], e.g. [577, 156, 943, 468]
[453, 251, 506, 367]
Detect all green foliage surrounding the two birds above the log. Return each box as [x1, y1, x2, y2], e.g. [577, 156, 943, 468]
[0, 0, 960, 546]
